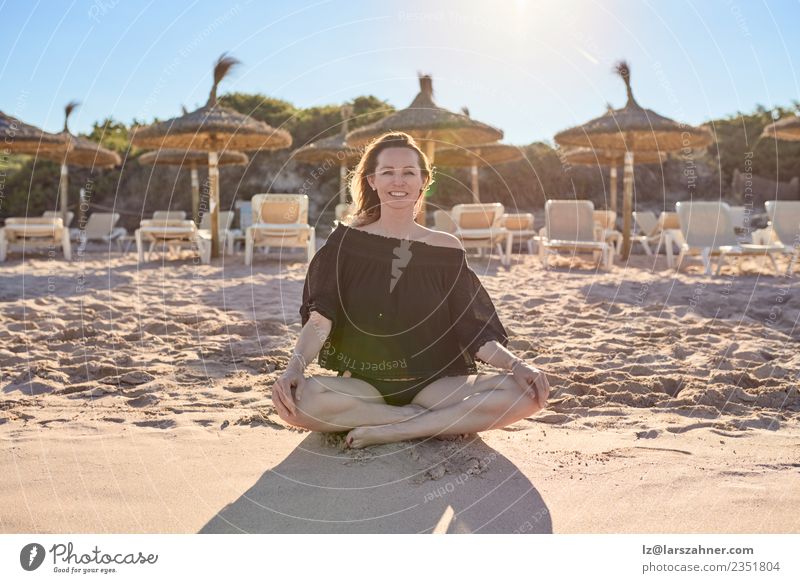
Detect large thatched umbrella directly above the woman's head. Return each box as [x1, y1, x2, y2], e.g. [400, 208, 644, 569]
[347, 75, 503, 223]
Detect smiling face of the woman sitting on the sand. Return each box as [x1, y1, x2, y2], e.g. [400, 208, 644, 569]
[367, 148, 423, 209]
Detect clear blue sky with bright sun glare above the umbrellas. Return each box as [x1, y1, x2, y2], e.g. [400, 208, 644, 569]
[0, 0, 800, 144]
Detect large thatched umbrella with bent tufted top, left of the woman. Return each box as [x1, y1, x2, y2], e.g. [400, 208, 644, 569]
[131, 54, 292, 257]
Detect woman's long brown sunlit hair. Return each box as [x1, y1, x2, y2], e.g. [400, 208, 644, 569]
[345, 132, 433, 227]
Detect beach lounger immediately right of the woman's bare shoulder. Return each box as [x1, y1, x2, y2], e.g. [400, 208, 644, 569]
[450, 202, 513, 266]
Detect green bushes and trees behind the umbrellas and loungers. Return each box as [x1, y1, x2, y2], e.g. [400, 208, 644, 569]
[0, 93, 800, 222]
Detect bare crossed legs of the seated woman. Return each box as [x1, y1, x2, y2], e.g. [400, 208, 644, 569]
[275, 374, 541, 447]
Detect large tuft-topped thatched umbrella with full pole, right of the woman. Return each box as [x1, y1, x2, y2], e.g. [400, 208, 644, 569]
[555, 61, 712, 259]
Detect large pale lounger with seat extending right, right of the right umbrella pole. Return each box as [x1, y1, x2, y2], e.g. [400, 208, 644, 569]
[675, 201, 778, 275]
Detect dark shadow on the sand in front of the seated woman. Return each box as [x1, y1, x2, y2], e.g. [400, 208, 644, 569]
[200, 433, 552, 533]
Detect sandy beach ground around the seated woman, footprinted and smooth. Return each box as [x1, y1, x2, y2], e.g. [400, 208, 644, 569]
[0, 242, 800, 533]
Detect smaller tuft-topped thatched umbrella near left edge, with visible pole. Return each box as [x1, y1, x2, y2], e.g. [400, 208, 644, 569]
[37, 101, 122, 225]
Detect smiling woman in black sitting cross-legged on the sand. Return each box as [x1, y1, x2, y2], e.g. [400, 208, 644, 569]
[272, 133, 550, 448]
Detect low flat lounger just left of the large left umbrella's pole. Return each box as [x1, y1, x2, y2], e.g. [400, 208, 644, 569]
[134, 219, 211, 264]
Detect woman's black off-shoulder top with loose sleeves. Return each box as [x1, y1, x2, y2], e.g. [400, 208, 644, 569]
[300, 224, 508, 380]
